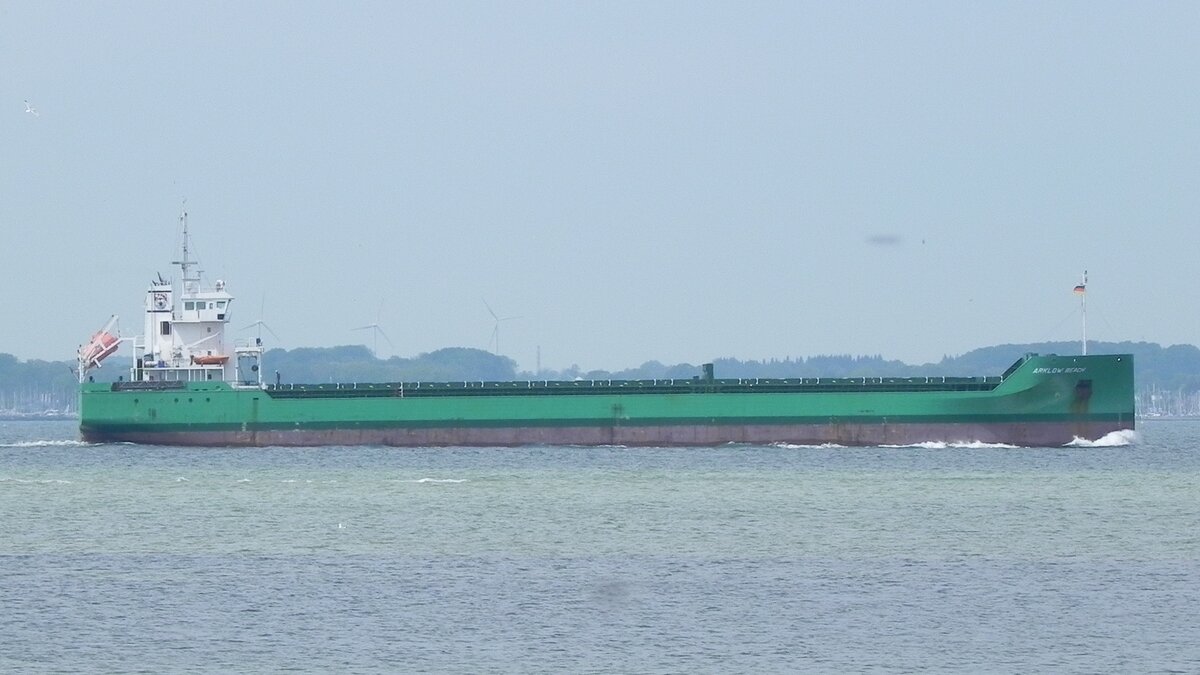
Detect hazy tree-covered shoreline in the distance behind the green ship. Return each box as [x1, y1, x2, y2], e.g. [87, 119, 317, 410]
[0, 342, 1200, 416]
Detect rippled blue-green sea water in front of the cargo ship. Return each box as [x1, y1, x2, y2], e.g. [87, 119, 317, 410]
[0, 420, 1200, 673]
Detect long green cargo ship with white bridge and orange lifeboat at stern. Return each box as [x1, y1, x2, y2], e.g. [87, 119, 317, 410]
[79, 216, 1134, 447]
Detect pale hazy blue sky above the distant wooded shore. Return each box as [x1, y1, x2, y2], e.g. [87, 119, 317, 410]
[0, 0, 1200, 370]
